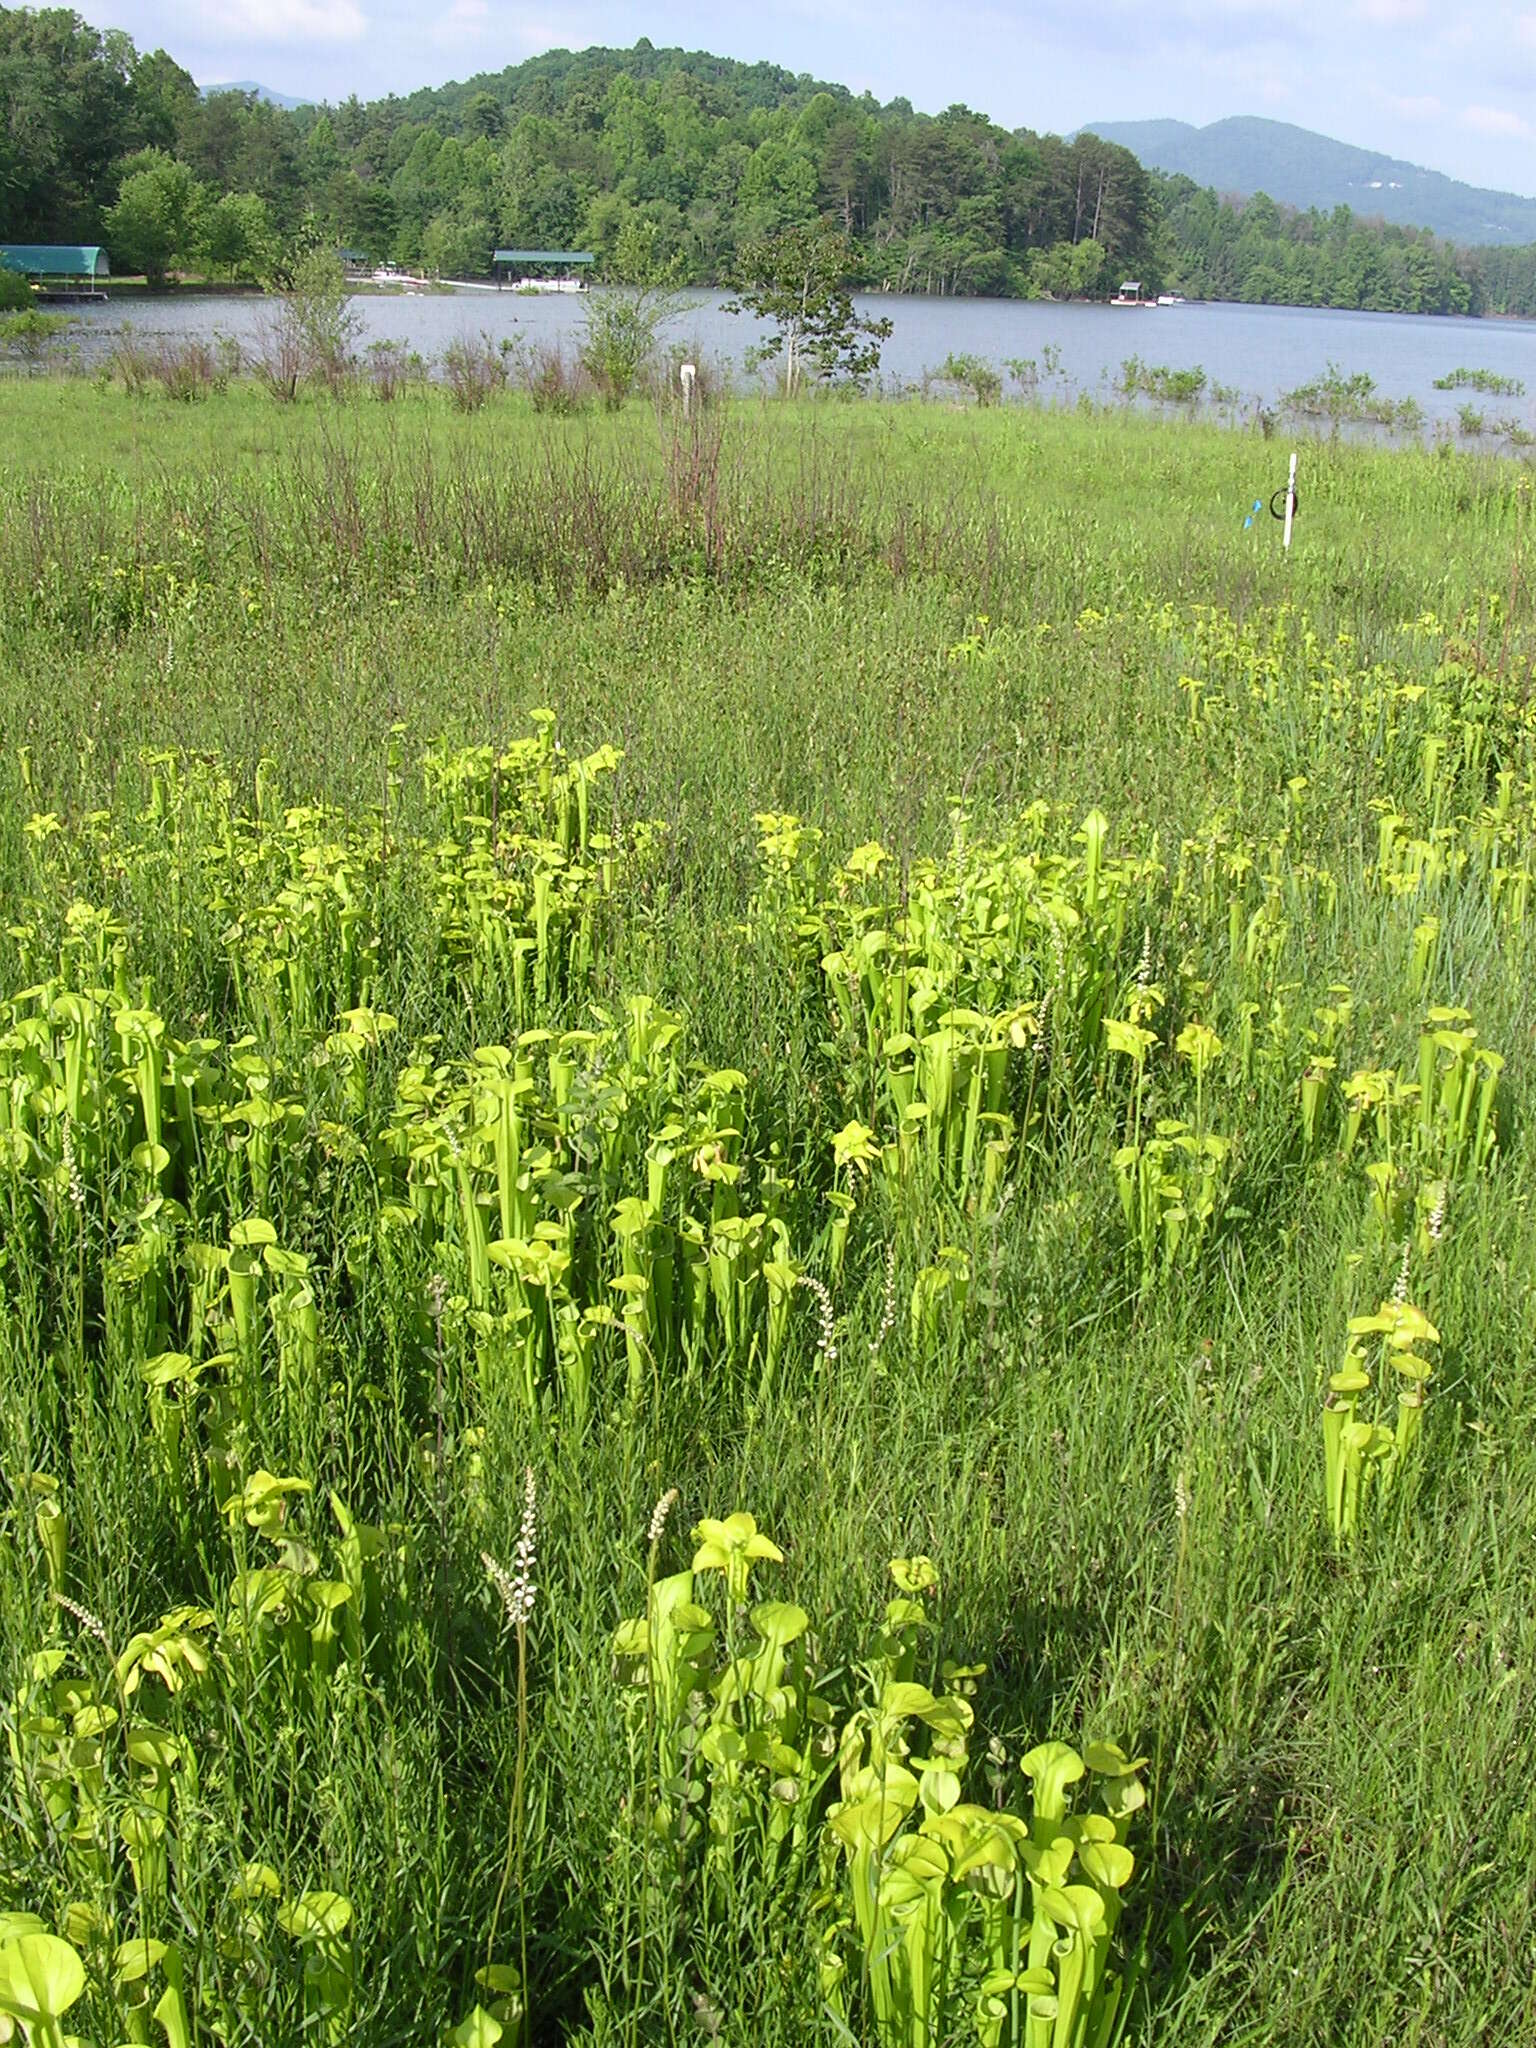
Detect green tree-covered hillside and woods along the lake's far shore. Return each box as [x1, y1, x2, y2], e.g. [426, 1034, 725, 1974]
[0, 8, 1536, 313]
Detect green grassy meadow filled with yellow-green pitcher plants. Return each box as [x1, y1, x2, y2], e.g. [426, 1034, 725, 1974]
[0, 377, 1536, 2048]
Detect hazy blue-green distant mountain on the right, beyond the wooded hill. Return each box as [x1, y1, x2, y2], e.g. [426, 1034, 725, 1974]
[1079, 115, 1536, 246]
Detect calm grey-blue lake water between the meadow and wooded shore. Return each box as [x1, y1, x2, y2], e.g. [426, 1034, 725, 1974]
[54, 289, 1536, 424]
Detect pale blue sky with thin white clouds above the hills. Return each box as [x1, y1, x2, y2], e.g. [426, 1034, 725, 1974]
[80, 0, 1536, 195]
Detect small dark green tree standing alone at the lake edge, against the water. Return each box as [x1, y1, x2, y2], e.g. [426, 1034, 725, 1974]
[725, 221, 891, 397]
